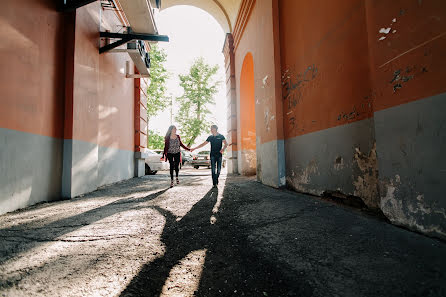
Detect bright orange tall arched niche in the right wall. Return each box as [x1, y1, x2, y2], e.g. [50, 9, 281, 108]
[239, 53, 257, 175]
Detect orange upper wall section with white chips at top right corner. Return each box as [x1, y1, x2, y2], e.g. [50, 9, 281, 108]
[366, 0, 446, 111]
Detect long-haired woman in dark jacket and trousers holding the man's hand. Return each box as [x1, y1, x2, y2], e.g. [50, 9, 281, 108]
[163, 125, 190, 187]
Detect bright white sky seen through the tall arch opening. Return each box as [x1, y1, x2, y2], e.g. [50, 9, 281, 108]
[149, 6, 227, 145]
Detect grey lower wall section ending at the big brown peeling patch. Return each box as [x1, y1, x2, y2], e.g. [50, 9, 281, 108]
[285, 119, 379, 208]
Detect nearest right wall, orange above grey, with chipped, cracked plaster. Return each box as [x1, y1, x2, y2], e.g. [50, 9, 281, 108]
[279, 0, 446, 238]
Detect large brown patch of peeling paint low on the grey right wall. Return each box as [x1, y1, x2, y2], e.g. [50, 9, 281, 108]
[353, 143, 379, 209]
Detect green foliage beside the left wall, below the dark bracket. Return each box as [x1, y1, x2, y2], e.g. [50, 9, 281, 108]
[147, 44, 170, 120]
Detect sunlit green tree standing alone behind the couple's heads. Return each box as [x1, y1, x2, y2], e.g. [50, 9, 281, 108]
[175, 58, 221, 146]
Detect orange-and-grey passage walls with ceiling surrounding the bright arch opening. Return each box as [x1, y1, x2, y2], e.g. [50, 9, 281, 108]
[0, 0, 446, 238]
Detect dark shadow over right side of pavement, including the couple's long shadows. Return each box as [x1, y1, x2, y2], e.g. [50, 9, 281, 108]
[121, 177, 446, 296]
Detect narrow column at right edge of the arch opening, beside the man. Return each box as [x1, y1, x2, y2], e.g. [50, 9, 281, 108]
[223, 33, 238, 173]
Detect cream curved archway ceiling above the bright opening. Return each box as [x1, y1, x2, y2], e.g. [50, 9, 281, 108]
[161, 0, 242, 33]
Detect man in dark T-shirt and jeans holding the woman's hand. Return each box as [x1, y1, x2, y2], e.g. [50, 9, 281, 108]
[191, 125, 228, 187]
